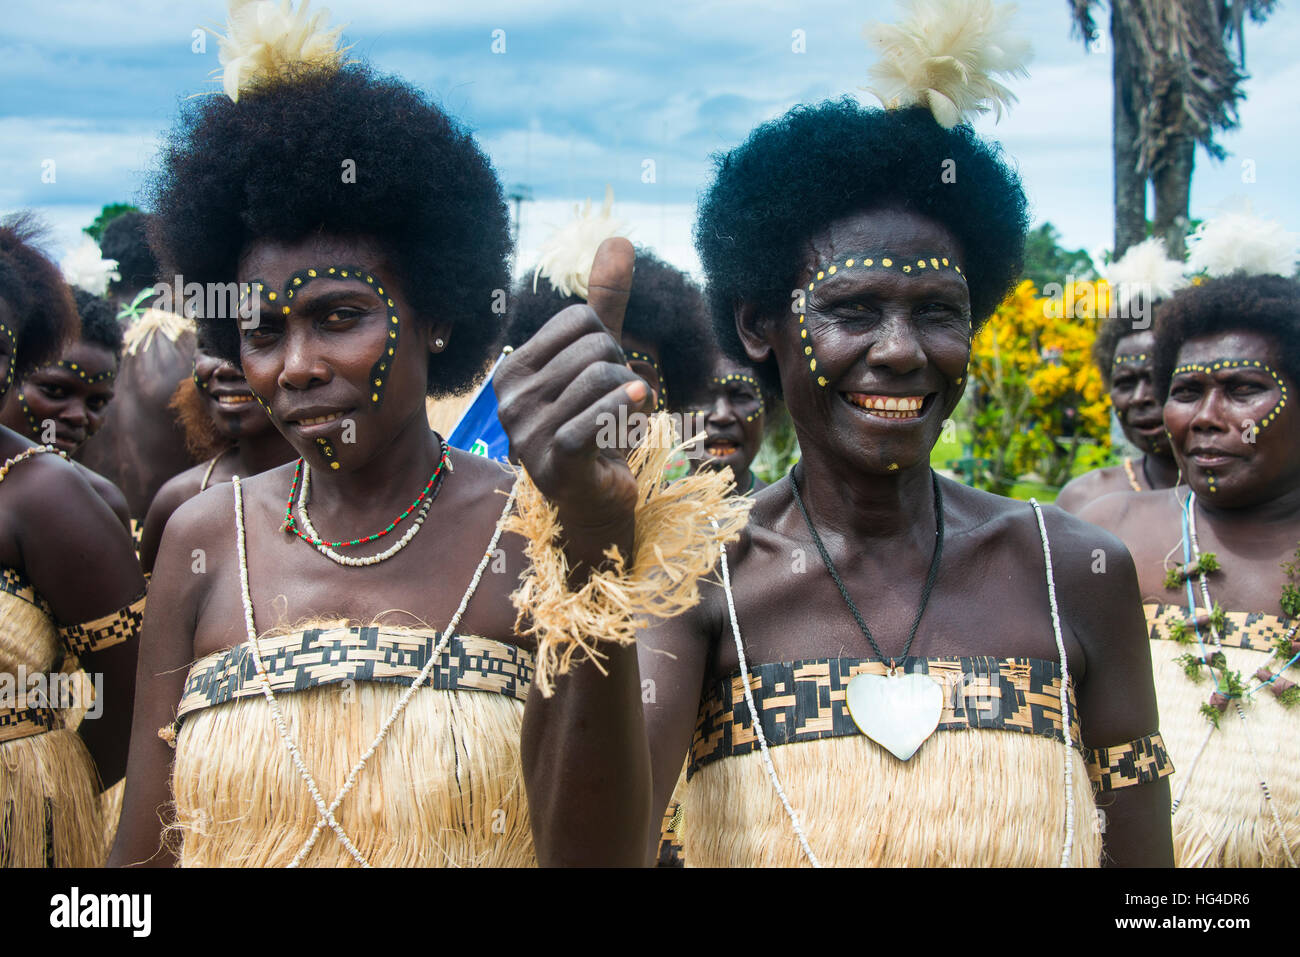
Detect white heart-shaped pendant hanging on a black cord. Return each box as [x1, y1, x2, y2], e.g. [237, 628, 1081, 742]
[846, 675, 944, 761]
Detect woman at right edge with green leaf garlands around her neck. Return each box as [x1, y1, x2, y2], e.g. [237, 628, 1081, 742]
[1080, 257, 1300, 867]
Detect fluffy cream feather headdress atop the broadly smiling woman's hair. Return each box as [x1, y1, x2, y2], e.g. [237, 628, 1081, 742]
[863, 0, 1032, 130]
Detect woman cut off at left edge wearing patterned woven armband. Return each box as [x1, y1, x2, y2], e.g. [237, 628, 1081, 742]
[0, 216, 144, 867]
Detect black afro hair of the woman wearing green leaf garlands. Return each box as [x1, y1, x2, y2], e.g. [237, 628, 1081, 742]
[1153, 273, 1300, 395]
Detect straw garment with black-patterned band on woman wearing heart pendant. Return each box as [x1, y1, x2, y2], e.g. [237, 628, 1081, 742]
[680, 657, 1107, 867]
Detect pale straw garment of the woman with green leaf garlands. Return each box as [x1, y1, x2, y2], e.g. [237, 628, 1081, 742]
[1145, 605, 1300, 867]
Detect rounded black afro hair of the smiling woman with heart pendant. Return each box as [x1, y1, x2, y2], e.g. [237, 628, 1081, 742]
[696, 98, 1028, 395]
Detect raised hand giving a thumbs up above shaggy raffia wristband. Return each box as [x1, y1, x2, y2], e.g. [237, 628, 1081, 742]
[493, 237, 653, 538]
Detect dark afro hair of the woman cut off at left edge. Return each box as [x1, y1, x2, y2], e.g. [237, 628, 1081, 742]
[0, 212, 77, 382]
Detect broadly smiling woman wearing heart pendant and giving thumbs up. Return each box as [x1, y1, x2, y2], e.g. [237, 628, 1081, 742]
[498, 3, 1171, 866]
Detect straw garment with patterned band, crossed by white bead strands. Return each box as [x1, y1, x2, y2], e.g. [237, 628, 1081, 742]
[173, 628, 537, 867]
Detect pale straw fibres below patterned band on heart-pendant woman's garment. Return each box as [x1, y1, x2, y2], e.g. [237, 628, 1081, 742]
[681, 729, 1101, 867]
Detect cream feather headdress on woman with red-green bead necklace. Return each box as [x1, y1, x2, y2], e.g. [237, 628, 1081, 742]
[215, 0, 350, 103]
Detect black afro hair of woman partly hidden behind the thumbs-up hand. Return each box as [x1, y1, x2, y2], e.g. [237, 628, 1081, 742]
[510, 246, 710, 400]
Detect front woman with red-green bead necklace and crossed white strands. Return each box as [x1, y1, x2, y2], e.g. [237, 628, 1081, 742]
[112, 3, 534, 866]
